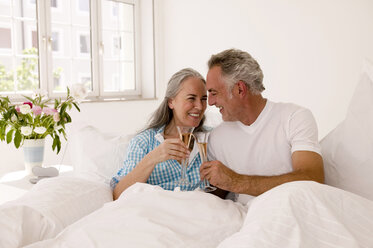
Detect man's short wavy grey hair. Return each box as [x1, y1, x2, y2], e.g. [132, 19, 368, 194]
[208, 49, 265, 95]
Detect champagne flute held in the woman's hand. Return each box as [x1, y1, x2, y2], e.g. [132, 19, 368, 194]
[176, 126, 194, 191]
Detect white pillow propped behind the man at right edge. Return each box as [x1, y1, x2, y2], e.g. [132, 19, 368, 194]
[320, 61, 373, 200]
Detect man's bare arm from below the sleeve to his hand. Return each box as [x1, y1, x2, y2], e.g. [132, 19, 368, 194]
[201, 151, 324, 196]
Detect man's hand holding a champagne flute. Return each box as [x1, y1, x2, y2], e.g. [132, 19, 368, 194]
[200, 160, 239, 191]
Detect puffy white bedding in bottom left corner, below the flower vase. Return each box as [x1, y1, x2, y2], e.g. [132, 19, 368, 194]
[0, 176, 113, 248]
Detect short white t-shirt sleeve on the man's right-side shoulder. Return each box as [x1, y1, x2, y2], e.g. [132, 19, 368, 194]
[288, 108, 321, 155]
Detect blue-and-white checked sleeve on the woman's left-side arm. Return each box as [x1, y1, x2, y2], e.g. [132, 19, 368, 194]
[110, 134, 149, 189]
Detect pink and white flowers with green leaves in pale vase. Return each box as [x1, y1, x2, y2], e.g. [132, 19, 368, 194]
[0, 88, 84, 172]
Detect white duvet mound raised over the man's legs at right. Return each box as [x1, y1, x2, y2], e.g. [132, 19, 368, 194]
[218, 182, 373, 248]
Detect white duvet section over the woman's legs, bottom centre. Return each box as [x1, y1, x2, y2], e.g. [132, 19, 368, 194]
[28, 183, 247, 248]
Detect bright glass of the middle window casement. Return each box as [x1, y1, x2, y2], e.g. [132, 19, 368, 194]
[50, 0, 92, 92]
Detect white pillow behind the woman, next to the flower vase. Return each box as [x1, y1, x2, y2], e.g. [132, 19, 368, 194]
[69, 126, 134, 183]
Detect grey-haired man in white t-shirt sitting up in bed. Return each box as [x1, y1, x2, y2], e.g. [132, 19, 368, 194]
[200, 49, 324, 203]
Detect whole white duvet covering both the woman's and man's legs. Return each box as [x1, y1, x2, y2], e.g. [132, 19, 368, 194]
[0, 179, 373, 248]
